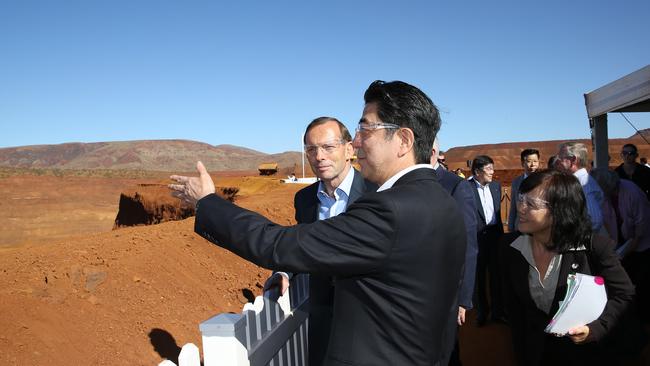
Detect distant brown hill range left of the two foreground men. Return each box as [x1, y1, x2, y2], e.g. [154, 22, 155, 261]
[0, 140, 302, 172]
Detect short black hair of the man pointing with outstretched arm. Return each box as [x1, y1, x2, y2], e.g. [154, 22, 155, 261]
[363, 80, 440, 164]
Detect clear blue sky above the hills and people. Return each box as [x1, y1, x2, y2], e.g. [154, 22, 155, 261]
[0, 0, 650, 153]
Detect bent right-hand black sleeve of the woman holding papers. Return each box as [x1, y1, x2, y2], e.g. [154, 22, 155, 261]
[588, 235, 634, 341]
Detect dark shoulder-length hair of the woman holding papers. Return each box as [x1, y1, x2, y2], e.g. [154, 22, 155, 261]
[519, 169, 591, 253]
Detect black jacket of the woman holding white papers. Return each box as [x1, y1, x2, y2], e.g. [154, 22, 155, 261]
[504, 235, 634, 365]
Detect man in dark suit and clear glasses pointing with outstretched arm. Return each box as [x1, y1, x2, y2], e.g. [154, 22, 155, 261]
[170, 81, 465, 366]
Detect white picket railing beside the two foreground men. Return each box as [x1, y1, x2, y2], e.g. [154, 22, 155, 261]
[159, 274, 309, 366]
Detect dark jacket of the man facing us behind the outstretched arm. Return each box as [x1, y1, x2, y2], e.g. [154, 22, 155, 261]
[293, 170, 377, 366]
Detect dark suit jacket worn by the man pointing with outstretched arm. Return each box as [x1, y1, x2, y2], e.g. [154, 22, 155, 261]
[195, 168, 465, 366]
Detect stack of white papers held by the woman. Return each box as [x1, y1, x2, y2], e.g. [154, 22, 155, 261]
[544, 273, 607, 336]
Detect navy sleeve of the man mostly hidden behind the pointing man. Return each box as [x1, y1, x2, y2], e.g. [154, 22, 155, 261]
[453, 180, 478, 309]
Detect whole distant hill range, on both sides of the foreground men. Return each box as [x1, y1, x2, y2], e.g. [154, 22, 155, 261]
[0, 129, 650, 174]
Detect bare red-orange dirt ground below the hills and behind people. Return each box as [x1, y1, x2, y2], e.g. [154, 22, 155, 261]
[0, 135, 650, 366]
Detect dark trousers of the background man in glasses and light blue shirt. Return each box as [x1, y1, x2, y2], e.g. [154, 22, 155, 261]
[476, 225, 505, 320]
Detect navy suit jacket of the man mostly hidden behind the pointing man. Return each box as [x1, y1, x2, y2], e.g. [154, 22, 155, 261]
[436, 165, 478, 309]
